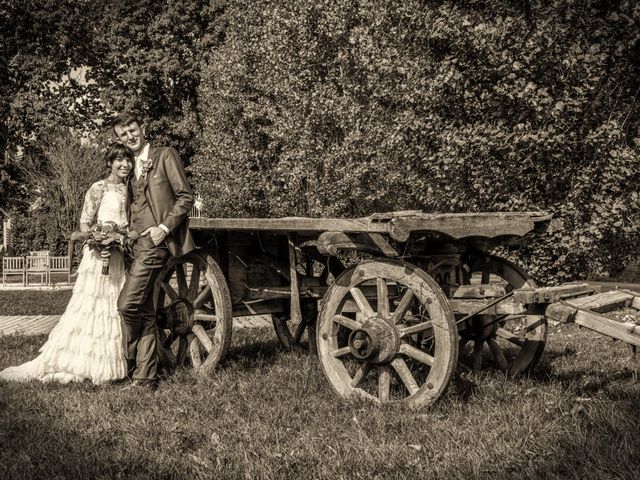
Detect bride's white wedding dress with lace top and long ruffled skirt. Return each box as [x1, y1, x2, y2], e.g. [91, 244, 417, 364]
[0, 180, 127, 384]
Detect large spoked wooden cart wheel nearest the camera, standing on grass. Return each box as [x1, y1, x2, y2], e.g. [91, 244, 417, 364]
[317, 259, 458, 408]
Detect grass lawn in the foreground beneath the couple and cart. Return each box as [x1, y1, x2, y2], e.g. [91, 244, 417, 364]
[0, 326, 640, 479]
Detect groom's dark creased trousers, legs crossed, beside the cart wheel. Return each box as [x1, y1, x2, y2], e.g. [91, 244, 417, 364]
[118, 235, 170, 381]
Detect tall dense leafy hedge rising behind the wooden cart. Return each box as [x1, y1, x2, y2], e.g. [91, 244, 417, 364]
[192, 0, 640, 281]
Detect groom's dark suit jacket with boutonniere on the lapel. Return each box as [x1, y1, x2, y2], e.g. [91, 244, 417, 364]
[125, 146, 195, 257]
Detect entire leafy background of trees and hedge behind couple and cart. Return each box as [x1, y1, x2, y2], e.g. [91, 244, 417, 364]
[0, 0, 640, 281]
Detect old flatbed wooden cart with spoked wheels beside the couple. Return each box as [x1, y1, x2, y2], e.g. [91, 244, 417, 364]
[155, 211, 551, 407]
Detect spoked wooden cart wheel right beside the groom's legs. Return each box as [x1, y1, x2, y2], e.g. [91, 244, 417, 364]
[154, 250, 233, 375]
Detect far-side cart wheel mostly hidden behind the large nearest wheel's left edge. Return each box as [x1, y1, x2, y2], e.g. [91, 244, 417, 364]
[271, 256, 344, 353]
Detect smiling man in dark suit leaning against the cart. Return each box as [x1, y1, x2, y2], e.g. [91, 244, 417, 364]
[111, 113, 195, 389]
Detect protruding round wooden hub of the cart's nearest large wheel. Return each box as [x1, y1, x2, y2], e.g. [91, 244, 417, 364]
[348, 317, 400, 363]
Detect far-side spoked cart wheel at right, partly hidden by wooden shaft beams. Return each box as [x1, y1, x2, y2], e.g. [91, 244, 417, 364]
[460, 255, 548, 373]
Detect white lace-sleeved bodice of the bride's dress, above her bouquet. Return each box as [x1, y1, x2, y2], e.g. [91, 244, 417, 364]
[80, 180, 127, 225]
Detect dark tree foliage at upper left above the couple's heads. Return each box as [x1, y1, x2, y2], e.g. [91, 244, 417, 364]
[0, 0, 219, 208]
